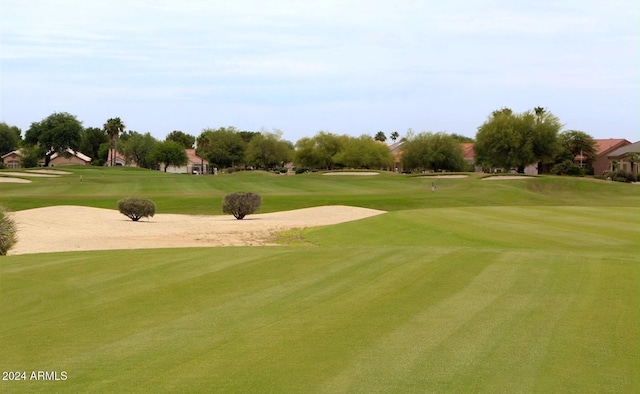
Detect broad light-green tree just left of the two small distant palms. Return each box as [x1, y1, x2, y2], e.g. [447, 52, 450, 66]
[334, 135, 393, 168]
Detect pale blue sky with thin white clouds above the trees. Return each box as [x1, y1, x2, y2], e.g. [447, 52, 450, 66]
[0, 0, 640, 142]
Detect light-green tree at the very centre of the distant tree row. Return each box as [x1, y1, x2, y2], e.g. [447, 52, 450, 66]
[295, 131, 344, 170]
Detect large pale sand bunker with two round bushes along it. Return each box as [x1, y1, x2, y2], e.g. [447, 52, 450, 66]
[9, 206, 384, 255]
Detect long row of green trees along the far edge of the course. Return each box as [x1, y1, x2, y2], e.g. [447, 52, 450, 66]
[0, 107, 608, 172]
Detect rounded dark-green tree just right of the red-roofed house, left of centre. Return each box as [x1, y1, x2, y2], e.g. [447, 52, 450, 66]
[198, 127, 247, 168]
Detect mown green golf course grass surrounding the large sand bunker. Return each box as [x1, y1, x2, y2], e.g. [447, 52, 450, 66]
[0, 168, 640, 393]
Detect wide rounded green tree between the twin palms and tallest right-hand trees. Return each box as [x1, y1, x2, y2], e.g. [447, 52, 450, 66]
[402, 132, 466, 171]
